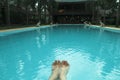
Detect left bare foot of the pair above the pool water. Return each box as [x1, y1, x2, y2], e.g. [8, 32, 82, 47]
[49, 60, 61, 80]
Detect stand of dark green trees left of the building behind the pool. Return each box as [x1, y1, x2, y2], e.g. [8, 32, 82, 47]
[0, 0, 57, 25]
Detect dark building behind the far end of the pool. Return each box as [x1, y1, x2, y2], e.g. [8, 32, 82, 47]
[53, 1, 97, 24]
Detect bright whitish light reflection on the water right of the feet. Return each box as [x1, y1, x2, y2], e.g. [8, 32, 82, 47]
[54, 48, 120, 80]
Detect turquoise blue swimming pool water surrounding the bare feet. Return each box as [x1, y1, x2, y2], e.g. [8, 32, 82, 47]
[0, 25, 120, 80]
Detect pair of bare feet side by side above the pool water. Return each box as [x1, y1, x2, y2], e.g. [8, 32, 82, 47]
[49, 60, 69, 80]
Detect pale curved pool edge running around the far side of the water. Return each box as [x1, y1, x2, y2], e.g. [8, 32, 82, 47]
[0, 24, 120, 36]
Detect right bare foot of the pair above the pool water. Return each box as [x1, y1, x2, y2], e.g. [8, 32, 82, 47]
[60, 61, 69, 80]
